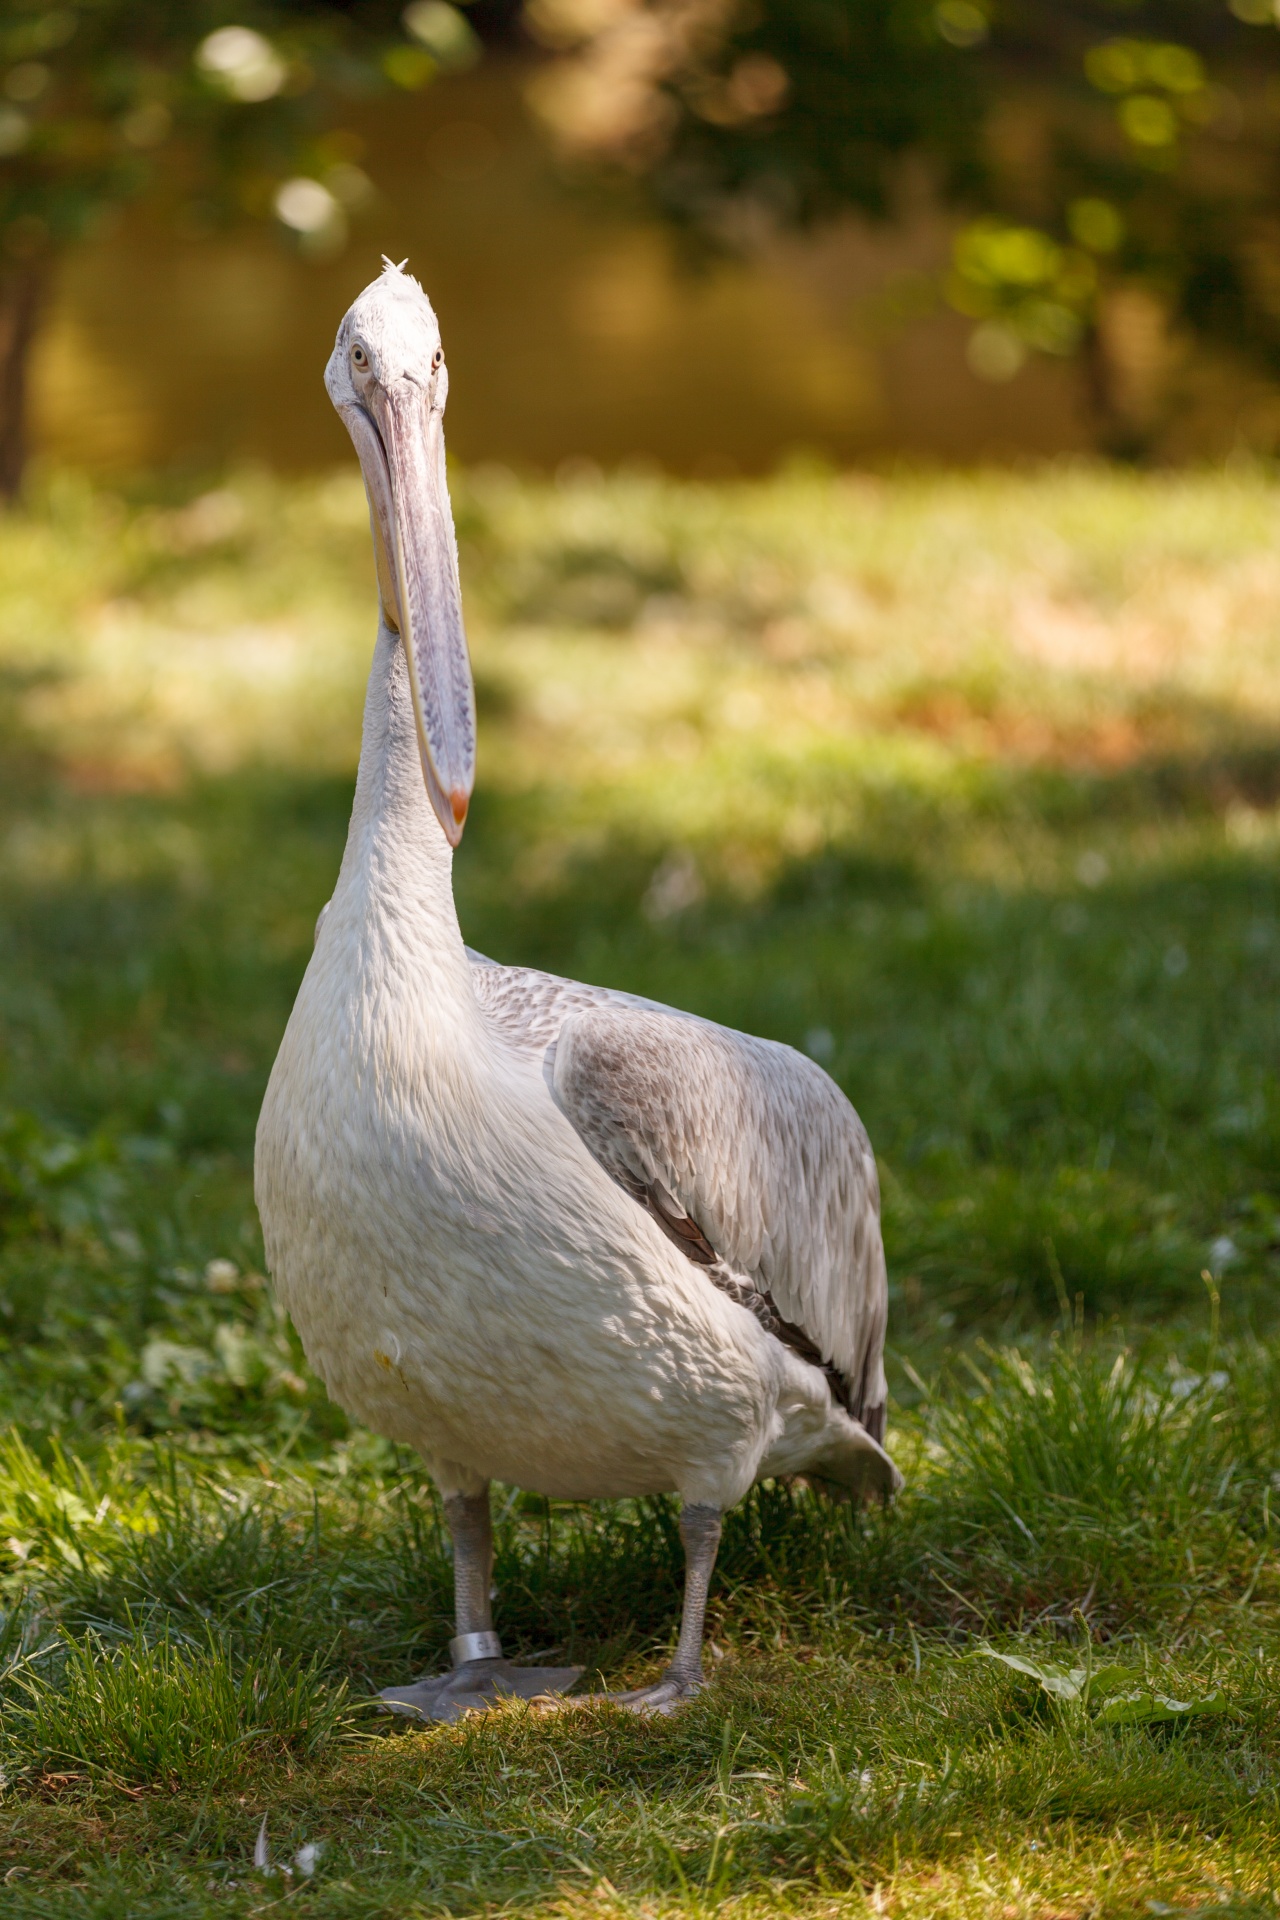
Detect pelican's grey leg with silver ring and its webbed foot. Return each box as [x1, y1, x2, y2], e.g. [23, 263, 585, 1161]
[378, 1486, 581, 1720]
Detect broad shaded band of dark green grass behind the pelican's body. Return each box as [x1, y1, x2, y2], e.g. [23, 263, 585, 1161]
[0, 722, 1280, 1444]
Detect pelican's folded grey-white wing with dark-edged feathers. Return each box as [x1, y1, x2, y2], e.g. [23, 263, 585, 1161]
[472, 956, 887, 1438]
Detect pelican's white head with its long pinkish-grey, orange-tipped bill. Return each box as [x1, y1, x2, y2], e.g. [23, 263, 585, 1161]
[324, 261, 476, 847]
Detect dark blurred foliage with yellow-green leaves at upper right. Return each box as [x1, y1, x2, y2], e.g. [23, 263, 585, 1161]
[528, 0, 1280, 439]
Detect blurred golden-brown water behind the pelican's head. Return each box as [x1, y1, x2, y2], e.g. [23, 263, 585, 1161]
[33, 44, 1090, 478]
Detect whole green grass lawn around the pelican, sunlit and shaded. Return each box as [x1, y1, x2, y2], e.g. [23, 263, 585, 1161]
[0, 456, 1280, 1920]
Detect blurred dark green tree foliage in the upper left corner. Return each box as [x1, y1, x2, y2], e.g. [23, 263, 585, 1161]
[0, 0, 478, 493]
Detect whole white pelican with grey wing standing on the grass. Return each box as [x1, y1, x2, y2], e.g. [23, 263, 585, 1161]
[255, 259, 902, 1720]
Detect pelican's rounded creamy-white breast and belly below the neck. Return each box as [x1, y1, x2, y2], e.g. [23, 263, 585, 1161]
[257, 921, 775, 1498]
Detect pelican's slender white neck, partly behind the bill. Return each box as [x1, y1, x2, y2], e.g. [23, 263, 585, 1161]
[334, 622, 476, 1008]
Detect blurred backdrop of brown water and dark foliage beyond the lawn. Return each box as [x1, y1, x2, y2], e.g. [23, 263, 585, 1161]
[12, 0, 1280, 474]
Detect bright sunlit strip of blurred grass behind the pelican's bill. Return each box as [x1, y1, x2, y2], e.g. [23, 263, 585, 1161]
[0, 467, 1280, 856]
